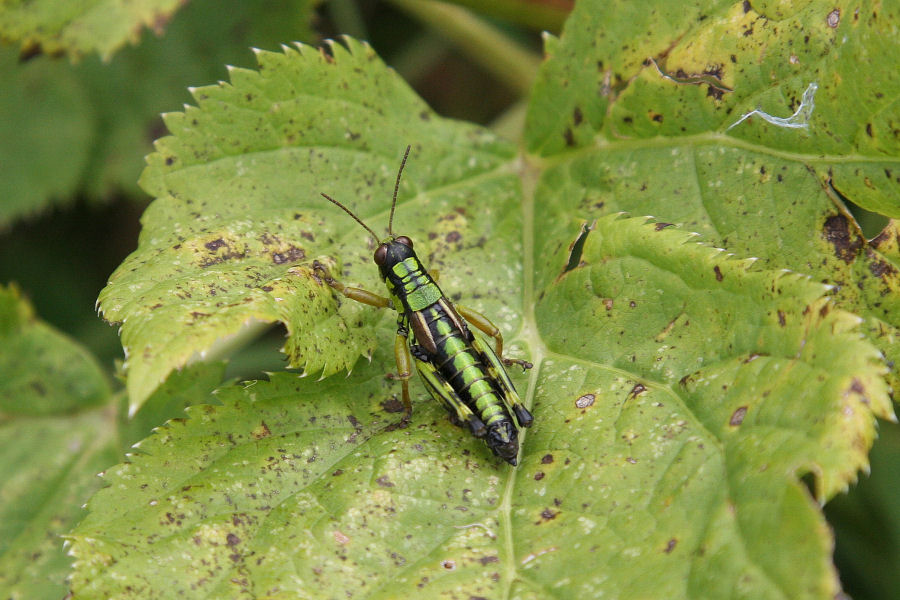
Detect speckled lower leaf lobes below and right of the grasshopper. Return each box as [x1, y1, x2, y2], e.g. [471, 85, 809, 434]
[72, 211, 889, 598]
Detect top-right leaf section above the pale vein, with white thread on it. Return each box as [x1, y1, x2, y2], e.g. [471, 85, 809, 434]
[526, 0, 900, 216]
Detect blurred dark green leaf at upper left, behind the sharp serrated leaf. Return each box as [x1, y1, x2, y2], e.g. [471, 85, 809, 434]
[0, 0, 315, 227]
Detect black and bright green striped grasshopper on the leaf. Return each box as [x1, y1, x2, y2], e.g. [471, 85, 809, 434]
[313, 146, 534, 466]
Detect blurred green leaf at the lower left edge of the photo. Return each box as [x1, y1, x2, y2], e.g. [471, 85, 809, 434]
[0, 288, 118, 600]
